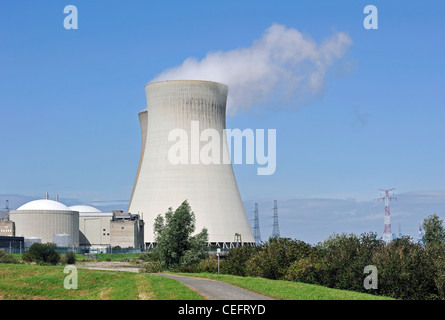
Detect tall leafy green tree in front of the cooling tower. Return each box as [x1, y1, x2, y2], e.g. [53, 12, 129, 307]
[153, 200, 208, 269]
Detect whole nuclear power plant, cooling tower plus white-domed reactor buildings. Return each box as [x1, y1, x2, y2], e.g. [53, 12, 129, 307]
[0, 80, 255, 252]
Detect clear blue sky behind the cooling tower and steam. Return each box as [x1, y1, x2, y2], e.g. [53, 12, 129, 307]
[0, 0, 445, 243]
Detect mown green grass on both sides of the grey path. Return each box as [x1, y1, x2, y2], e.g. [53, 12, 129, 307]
[0, 264, 389, 300]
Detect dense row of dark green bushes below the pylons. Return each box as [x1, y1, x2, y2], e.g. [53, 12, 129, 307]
[215, 228, 445, 299]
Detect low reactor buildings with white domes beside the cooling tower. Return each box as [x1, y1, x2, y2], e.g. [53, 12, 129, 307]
[0, 198, 144, 252]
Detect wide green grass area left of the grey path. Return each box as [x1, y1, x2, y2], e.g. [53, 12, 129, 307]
[0, 264, 203, 300]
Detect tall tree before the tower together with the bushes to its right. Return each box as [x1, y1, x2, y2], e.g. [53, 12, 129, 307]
[145, 201, 445, 299]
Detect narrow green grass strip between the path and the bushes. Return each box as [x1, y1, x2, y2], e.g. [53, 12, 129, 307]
[173, 273, 394, 300]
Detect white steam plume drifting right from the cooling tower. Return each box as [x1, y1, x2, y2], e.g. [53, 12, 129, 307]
[150, 24, 352, 115]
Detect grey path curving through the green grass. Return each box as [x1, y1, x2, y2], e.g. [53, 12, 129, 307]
[157, 273, 272, 300]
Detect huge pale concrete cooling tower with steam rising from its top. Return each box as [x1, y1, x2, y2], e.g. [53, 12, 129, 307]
[128, 80, 255, 247]
